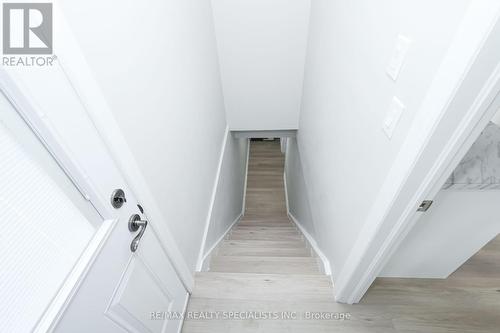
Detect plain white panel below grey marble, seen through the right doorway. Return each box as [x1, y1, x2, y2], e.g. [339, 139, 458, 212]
[380, 190, 500, 278]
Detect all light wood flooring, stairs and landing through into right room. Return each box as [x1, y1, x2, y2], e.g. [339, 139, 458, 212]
[183, 142, 500, 333]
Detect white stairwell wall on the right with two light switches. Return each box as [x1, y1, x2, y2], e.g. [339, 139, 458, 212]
[298, 0, 470, 278]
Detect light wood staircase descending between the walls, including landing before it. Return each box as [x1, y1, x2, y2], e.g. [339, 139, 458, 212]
[183, 141, 339, 333]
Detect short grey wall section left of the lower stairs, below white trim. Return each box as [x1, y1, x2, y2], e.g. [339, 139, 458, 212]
[204, 133, 248, 255]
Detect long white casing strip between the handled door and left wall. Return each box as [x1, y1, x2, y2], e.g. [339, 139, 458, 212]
[48, 3, 194, 291]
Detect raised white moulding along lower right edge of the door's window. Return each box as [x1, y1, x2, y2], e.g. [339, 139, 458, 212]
[33, 219, 118, 333]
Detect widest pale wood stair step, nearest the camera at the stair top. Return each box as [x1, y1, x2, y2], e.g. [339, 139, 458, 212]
[192, 272, 333, 301]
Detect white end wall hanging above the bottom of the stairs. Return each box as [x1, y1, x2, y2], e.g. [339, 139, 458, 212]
[212, 0, 310, 130]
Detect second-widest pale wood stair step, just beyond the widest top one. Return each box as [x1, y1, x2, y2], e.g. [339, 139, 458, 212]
[210, 256, 321, 275]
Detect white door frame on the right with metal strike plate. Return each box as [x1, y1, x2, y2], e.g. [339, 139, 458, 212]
[335, 0, 500, 304]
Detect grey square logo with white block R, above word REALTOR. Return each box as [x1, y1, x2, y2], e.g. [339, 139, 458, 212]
[3, 3, 52, 54]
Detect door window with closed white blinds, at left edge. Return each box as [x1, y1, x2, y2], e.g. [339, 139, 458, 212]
[0, 93, 98, 332]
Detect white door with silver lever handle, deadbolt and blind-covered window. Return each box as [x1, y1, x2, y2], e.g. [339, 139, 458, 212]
[0, 59, 188, 333]
